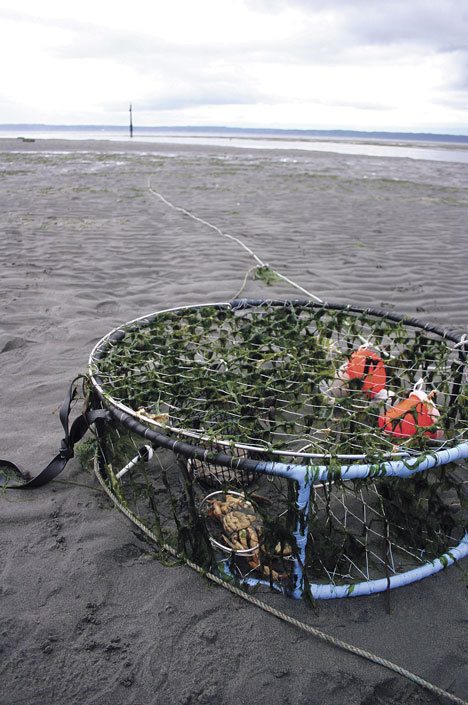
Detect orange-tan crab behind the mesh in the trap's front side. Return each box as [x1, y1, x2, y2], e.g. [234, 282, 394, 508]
[208, 494, 292, 580]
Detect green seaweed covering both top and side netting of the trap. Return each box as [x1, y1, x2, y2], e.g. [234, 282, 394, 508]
[89, 304, 467, 586]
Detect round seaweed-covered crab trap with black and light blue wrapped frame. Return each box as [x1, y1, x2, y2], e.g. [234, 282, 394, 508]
[89, 299, 468, 598]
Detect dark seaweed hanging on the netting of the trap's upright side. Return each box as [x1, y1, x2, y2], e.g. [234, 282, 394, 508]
[87, 420, 463, 587]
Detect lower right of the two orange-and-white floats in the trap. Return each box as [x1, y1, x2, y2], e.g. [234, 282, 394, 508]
[378, 390, 444, 439]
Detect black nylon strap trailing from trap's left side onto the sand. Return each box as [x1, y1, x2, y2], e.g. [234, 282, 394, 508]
[0, 380, 110, 490]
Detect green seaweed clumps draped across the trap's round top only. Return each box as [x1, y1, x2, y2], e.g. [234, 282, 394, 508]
[94, 307, 460, 454]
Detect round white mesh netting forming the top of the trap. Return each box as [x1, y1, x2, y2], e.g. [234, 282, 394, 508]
[92, 298, 467, 458]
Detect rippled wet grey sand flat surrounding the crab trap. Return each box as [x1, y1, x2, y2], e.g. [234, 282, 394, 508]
[0, 139, 468, 705]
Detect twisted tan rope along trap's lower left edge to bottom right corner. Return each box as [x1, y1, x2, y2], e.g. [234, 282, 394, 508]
[94, 457, 468, 705]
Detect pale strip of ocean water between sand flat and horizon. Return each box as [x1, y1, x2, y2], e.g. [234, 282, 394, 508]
[0, 125, 468, 164]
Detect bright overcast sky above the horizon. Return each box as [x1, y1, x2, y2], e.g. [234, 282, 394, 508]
[0, 0, 468, 134]
